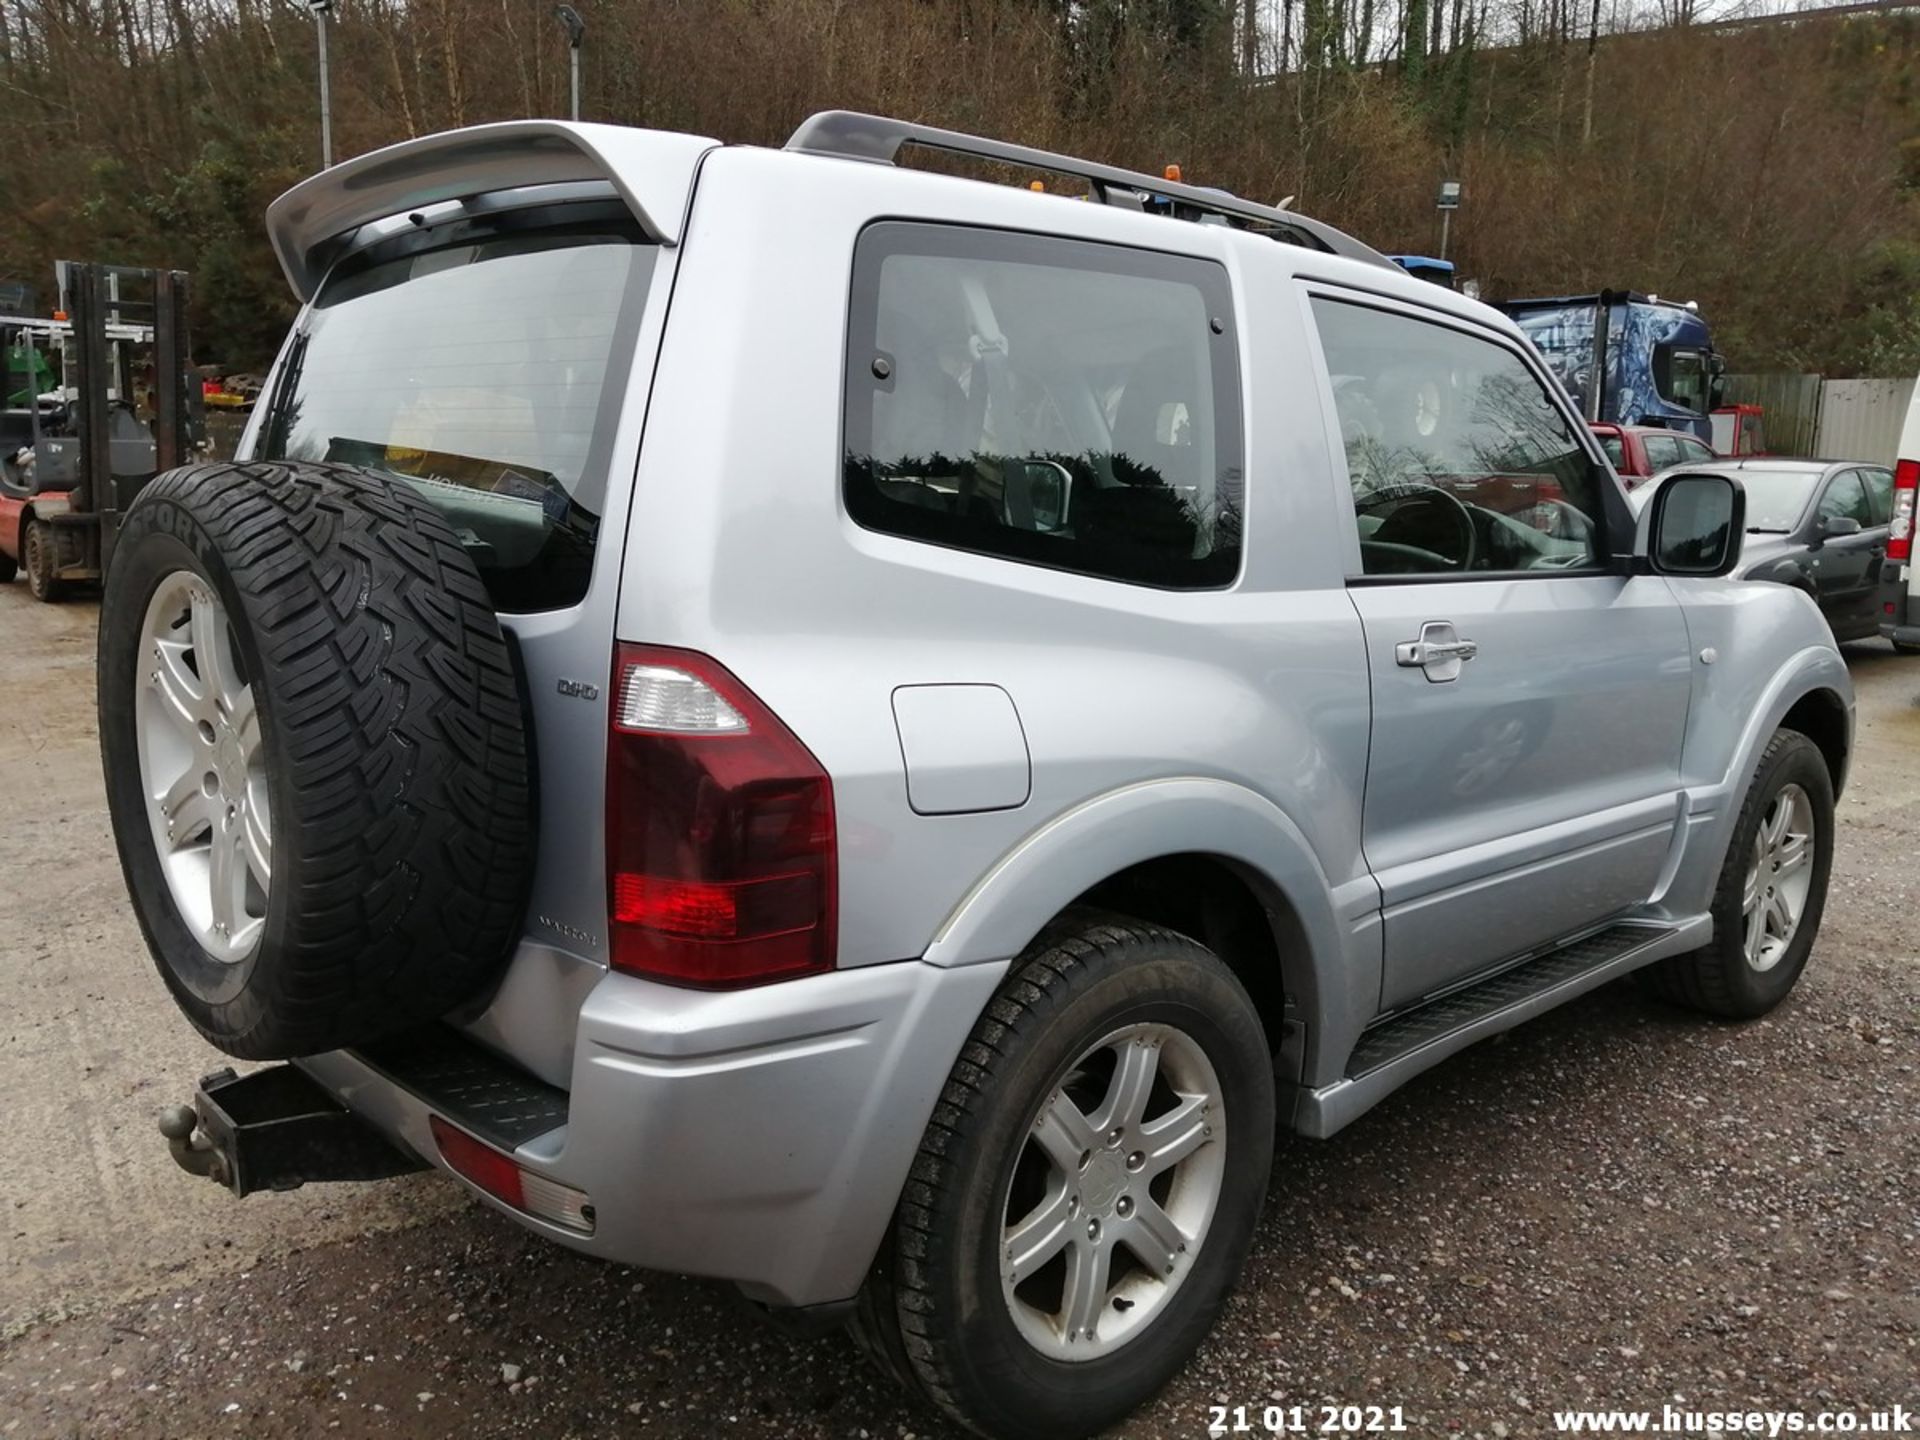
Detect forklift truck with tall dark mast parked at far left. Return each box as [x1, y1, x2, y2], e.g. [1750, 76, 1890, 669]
[0, 261, 205, 601]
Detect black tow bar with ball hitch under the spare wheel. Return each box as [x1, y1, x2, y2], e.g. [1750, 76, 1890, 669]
[159, 1066, 426, 1194]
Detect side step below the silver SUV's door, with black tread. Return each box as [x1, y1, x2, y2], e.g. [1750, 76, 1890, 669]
[1296, 916, 1689, 1137]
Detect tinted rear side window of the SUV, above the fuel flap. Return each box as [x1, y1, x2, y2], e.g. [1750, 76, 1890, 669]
[845, 223, 1240, 588]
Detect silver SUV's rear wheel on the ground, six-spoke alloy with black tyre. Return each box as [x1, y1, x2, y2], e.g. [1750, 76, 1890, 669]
[856, 912, 1275, 1440]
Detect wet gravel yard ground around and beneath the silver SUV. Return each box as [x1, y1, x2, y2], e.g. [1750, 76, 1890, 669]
[0, 588, 1920, 1440]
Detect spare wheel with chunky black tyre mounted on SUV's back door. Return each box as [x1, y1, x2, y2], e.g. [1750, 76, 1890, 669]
[98, 463, 534, 1060]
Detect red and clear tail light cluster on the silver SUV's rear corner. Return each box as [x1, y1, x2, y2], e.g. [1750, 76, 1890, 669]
[607, 645, 837, 989]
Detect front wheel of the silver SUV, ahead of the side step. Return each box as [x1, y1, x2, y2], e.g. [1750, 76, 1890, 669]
[1642, 730, 1834, 1020]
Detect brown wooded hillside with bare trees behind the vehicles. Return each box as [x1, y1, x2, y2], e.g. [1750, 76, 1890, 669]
[0, 0, 1920, 376]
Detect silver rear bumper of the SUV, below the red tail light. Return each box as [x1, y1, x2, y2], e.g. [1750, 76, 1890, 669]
[298, 962, 1006, 1306]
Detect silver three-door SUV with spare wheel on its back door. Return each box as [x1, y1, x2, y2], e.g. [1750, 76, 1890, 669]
[100, 113, 1853, 1438]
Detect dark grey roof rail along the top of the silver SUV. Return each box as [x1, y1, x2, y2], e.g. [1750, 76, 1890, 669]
[787, 109, 1394, 269]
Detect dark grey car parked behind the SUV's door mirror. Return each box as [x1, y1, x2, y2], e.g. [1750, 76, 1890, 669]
[1632, 459, 1893, 639]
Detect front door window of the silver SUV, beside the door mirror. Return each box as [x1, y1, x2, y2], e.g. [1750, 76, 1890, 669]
[1313, 300, 1605, 574]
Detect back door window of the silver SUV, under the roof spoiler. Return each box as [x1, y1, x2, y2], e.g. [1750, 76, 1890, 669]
[255, 215, 657, 611]
